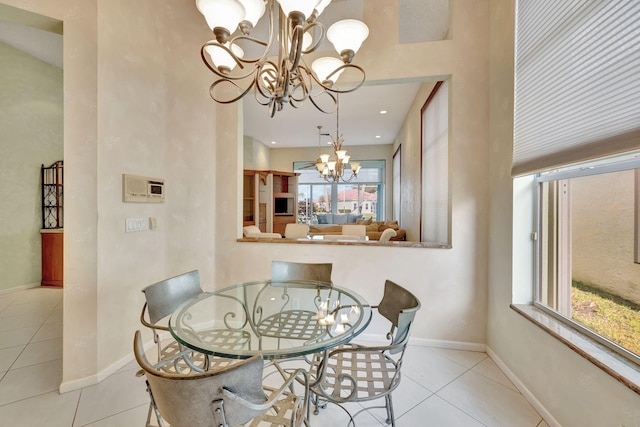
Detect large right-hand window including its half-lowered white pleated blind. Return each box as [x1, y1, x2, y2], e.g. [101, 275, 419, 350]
[512, 0, 640, 383]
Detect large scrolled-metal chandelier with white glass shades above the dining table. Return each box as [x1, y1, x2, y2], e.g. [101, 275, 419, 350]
[196, 0, 369, 117]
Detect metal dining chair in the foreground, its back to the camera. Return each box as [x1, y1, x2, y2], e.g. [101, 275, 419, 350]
[133, 331, 309, 427]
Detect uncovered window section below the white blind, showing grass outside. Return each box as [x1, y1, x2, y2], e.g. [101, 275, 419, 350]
[536, 155, 640, 362]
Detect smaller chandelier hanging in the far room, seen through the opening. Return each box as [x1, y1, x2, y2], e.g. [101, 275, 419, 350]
[316, 98, 360, 182]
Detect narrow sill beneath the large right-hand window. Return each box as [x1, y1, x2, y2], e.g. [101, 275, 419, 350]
[511, 304, 640, 394]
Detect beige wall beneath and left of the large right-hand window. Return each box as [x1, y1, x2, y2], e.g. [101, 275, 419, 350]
[488, 0, 640, 427]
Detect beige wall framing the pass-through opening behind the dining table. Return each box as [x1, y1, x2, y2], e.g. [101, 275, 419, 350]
[216, 0, 489, 348]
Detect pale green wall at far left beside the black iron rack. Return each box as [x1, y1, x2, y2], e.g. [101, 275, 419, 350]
[0, 43, 63, 293]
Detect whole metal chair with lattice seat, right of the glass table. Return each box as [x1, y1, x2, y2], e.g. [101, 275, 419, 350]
[311, 280, 420, 426]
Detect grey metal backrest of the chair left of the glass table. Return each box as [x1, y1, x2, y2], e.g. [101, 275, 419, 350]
[142, 270, 203, 324]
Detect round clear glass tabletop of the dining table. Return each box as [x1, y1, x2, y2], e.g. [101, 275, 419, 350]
[169, 280, 371, 359]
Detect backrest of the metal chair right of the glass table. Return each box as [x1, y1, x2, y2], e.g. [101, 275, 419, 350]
[378, 280, 420, 353]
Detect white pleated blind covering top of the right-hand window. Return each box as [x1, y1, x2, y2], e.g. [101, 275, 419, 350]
[512, 0, 640, 176]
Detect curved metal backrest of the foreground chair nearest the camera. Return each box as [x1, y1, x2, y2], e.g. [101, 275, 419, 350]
[133, 331, 267, 427]
